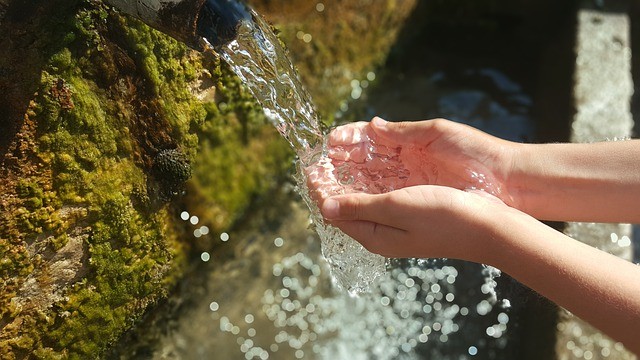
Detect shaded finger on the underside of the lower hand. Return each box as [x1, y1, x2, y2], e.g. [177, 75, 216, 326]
[331, 221, 407, 257]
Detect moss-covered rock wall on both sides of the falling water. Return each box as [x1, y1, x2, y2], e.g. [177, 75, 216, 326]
[0, 0, 413, 359]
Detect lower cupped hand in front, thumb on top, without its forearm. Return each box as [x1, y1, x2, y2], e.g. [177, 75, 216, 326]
[321, 185, 519, 263]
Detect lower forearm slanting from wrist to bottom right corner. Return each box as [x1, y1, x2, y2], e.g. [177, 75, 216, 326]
[489, 214, 640, 354]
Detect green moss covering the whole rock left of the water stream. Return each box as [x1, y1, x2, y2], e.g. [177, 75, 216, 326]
[0, 0, 292, 359]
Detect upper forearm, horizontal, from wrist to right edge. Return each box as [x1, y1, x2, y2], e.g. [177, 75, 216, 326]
[508, 140, 640, 223]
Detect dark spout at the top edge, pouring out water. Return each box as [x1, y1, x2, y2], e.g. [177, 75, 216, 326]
[104, 0, 251, 50]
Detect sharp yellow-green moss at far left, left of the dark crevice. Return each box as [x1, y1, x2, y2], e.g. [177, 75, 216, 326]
[0, 2, 191, 358]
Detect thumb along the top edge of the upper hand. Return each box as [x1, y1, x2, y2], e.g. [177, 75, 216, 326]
[371, 116, 446, 144]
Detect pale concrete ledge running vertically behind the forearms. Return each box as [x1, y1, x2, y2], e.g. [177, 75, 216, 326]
[556, 9, 636, 360]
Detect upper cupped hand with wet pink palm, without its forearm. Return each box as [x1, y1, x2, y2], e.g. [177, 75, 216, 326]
[329, 117, 516, 205]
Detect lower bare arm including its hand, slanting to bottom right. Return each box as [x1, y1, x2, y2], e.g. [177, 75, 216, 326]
[322, 185, 640, 354]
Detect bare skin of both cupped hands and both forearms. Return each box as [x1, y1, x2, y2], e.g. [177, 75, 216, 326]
[310, 118, 640, 354]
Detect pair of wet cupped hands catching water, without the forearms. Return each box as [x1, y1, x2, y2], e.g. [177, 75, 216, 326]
[307, 118, 517, 262]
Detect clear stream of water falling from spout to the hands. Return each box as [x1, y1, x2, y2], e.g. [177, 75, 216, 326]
[202, 11, 324, 164]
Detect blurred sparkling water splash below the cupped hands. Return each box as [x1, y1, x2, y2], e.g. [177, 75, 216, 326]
[202, 248, 510, 360]
